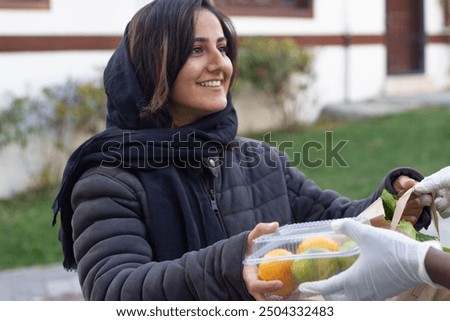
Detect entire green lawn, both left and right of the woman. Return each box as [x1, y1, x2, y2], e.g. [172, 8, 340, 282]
[0, 108, 450, 269]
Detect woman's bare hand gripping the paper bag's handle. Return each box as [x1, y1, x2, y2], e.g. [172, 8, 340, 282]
[392, 175, 424, 224]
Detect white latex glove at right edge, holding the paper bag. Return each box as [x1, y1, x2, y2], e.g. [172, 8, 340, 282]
[414, 166, 450, 218]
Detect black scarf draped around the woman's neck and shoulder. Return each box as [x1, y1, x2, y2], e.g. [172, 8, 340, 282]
[53, 103, 237, 269]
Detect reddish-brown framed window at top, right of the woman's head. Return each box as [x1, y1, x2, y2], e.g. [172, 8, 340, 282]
[215, 0, 313, 17]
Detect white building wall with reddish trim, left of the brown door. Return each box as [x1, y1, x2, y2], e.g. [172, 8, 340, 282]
[233, 0, 385, 106]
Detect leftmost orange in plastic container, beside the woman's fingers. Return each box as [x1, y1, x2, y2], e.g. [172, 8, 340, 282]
[258, 249, 297, 296]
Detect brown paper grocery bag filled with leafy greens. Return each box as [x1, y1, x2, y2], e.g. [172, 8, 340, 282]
[359, 188, 450, 301]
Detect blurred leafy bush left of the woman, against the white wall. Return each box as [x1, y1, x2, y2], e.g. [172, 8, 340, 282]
[0, 79, 106, 149]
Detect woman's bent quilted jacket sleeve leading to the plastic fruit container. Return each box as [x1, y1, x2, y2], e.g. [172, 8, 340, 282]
[72, 170, 252, 301]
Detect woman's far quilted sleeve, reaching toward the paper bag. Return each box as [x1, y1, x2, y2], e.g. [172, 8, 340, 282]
[285, 156, 430, 228]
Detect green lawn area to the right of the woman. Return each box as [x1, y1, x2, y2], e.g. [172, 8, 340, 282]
[254, 108, 450, 198]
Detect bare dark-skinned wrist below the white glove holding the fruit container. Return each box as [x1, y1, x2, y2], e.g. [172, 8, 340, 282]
[425, 248, 450, 289]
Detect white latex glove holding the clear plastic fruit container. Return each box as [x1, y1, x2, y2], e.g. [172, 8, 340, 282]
[299, 219, 440, 300]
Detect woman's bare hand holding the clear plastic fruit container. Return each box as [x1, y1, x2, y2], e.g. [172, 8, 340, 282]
[242, 222, 283, 301]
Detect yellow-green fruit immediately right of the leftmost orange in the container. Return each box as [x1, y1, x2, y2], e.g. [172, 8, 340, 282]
[291, 247, 339, 284]
